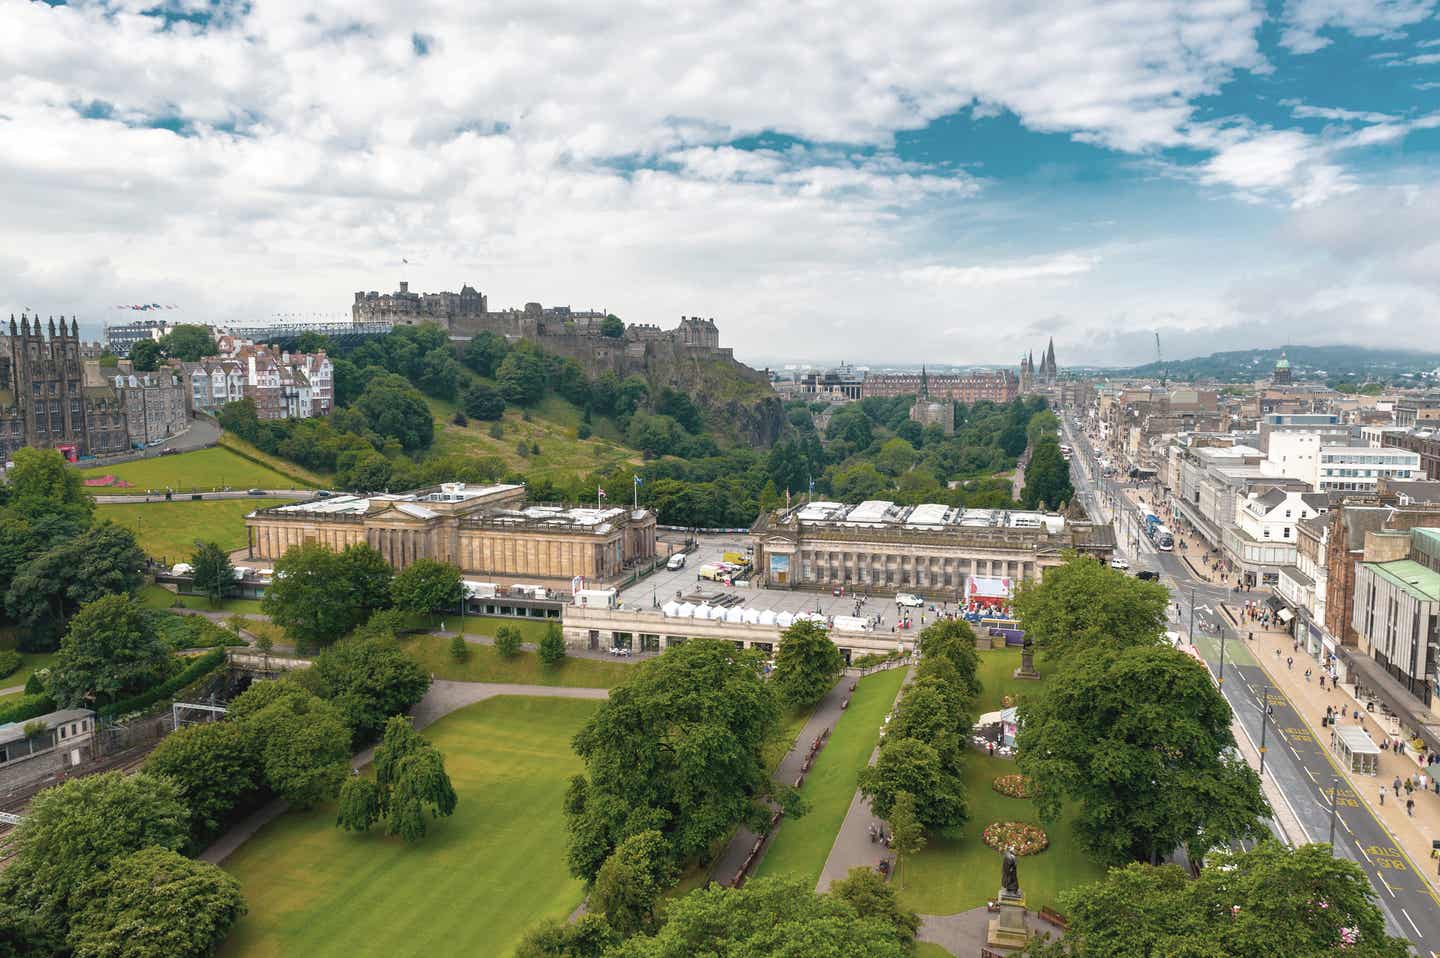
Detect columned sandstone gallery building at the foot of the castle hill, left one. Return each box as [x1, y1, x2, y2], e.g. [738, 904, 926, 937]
[245, 483, 655, 588]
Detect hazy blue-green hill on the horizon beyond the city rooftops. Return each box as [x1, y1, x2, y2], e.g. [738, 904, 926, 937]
[1107, 346, 1440, 382]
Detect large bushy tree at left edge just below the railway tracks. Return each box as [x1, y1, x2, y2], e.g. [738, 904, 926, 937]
[0, 772, 189, 938]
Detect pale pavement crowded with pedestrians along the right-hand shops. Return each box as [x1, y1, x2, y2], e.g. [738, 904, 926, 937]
[1231, 609, 1440, 889]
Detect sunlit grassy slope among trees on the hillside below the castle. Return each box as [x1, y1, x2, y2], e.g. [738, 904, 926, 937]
[428, 396, 642, 478]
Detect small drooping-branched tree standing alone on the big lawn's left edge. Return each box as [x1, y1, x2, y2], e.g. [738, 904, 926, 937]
[336, 715, 456, 841]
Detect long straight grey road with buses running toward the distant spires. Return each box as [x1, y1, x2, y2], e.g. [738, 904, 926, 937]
[1064, 419, 1440, 955]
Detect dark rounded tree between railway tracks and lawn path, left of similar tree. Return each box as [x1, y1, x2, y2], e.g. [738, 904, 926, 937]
[145, 722, 261, 849]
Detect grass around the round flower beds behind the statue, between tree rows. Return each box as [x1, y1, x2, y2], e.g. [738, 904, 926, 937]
[900, 648, 1104, 915]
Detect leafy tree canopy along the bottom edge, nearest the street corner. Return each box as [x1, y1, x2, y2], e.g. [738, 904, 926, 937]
[1024, 841, 1411, 958]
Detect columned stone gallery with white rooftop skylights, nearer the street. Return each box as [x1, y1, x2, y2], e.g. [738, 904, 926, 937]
[750, 500, 1115, 599]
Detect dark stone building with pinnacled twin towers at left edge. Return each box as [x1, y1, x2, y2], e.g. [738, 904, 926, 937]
[0, 314, 130, 460]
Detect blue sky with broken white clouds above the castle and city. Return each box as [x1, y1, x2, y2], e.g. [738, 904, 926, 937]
[0, 0, 1440, 364]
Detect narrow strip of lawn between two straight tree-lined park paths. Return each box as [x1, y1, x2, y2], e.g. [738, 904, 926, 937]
[756, 668, 906, 883]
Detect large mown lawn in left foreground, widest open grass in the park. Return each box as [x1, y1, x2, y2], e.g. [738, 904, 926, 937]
[220, 697, 599, 958]
